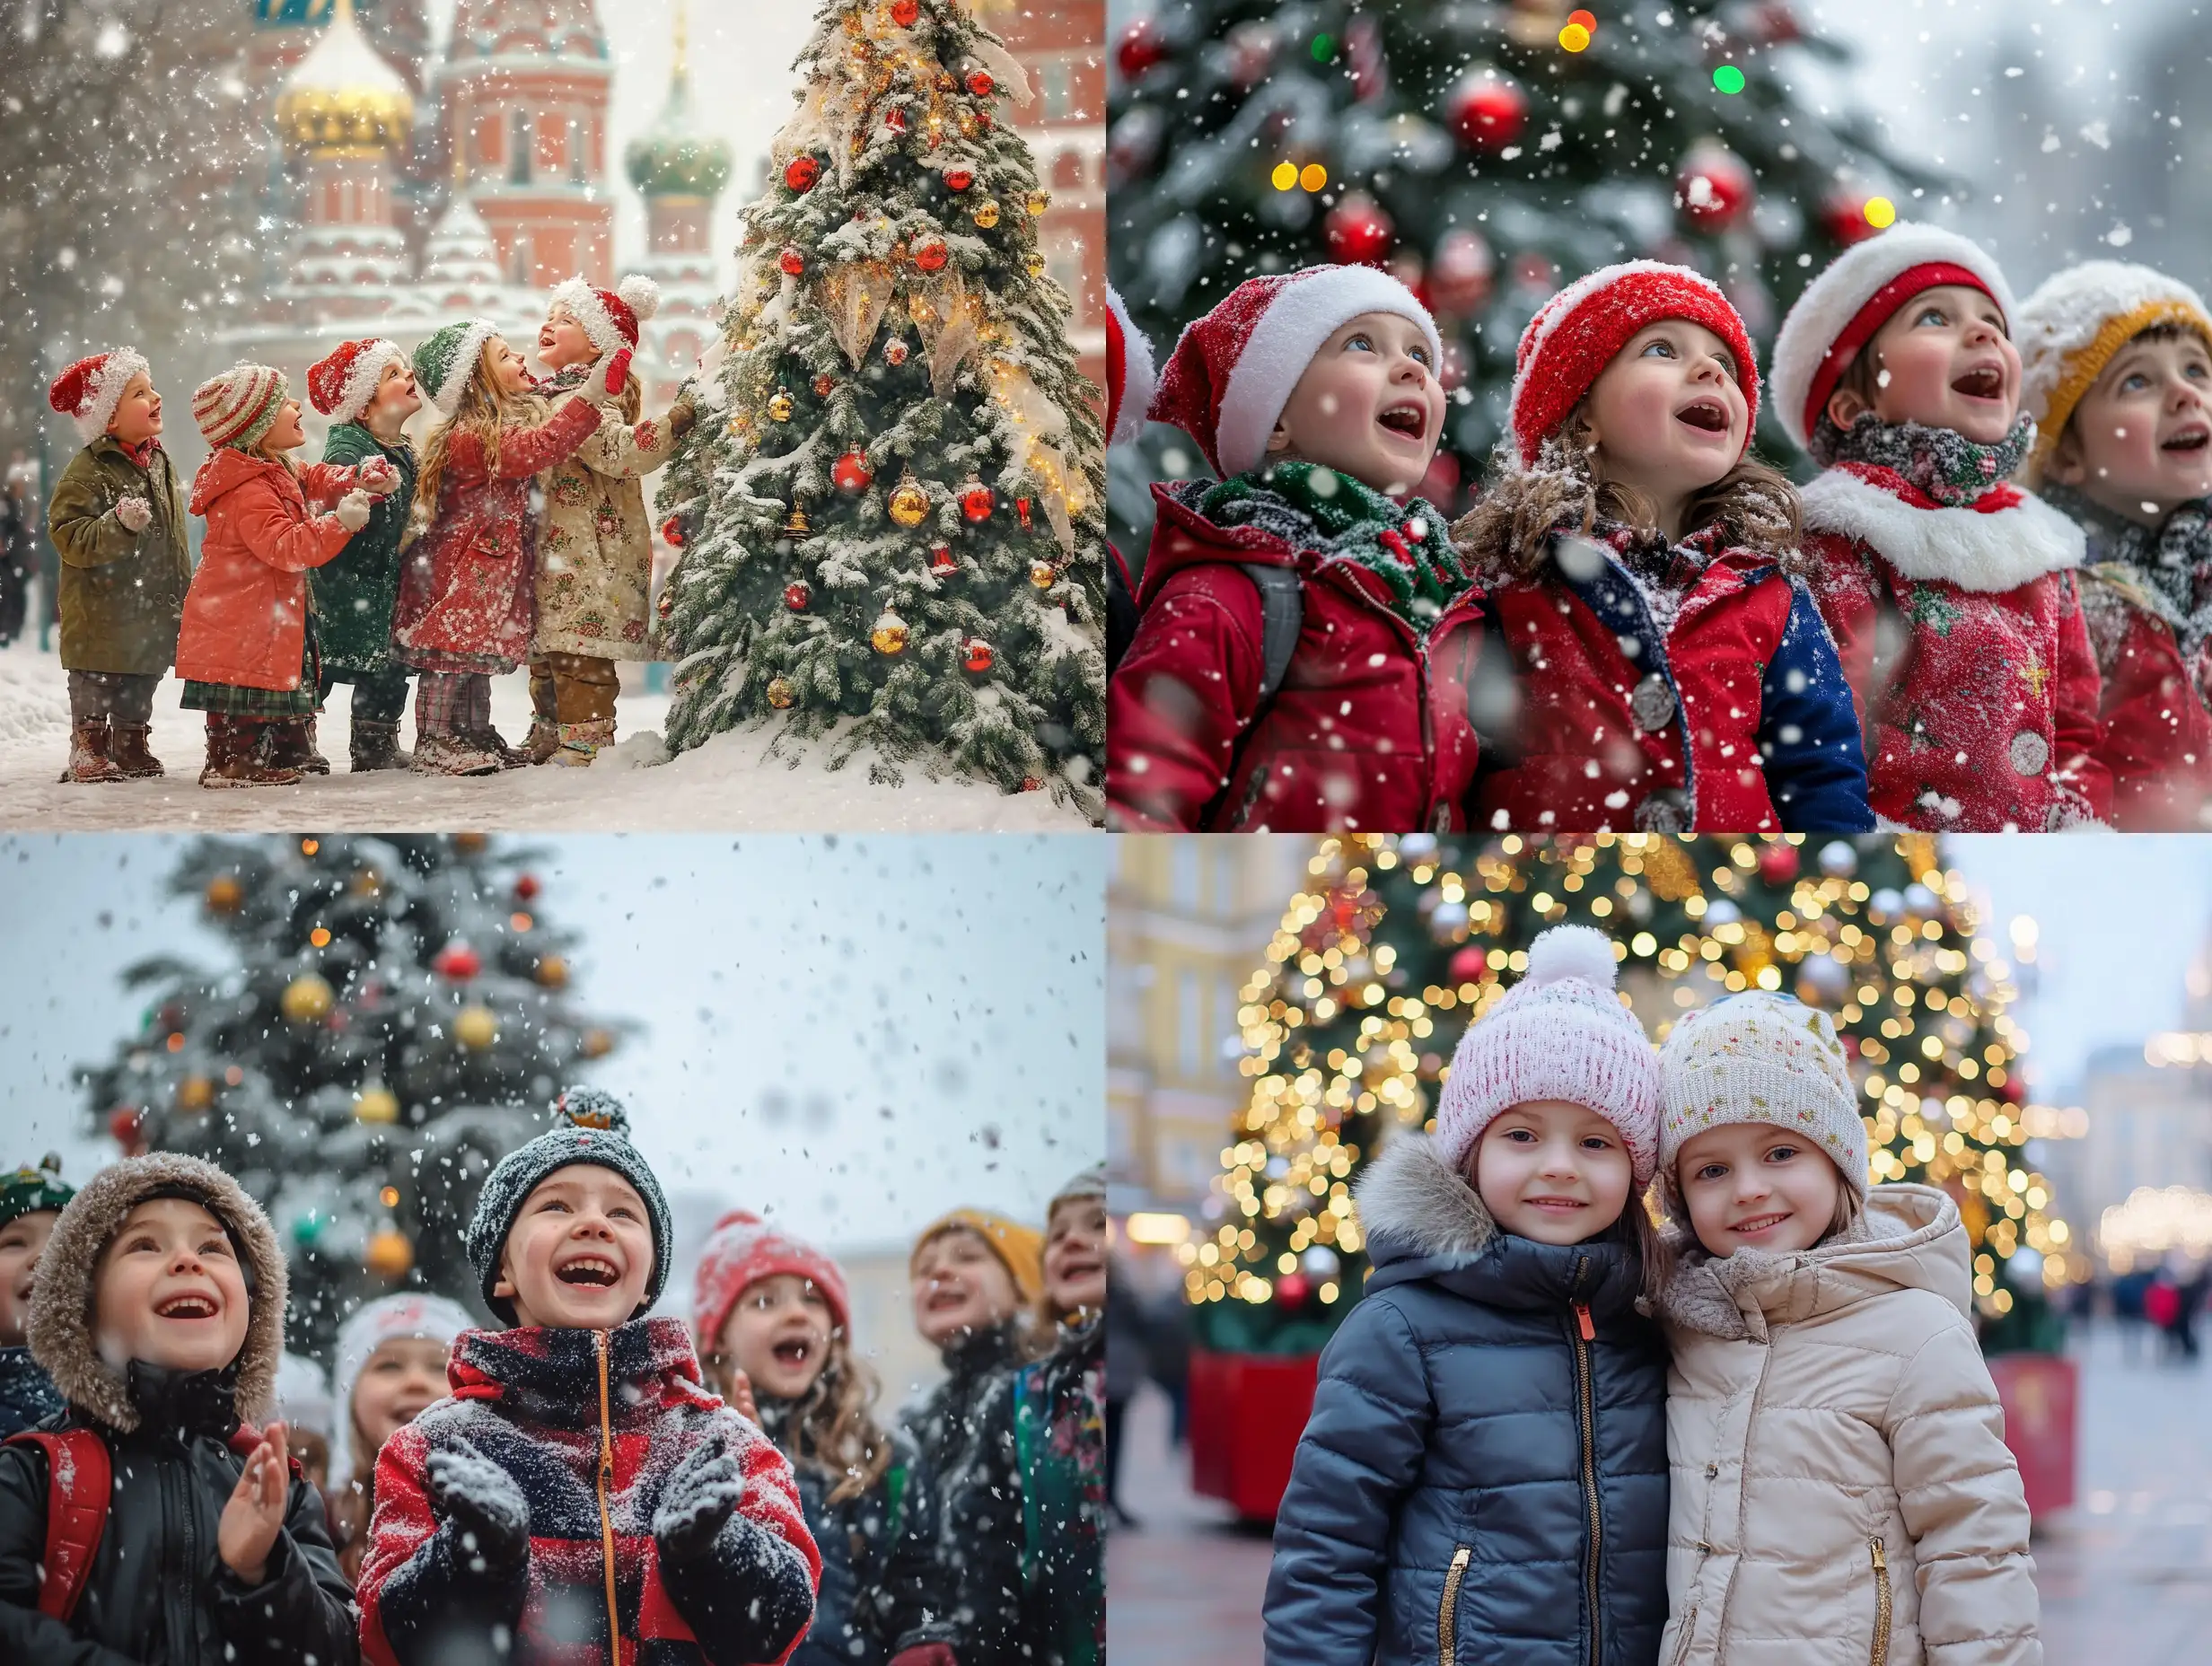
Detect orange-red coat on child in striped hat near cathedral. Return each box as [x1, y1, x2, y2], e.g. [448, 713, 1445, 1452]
[177, 444, 354, 690]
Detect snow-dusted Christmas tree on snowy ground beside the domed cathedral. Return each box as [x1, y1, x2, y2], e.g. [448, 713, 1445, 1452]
[662, 0, 1106, 814]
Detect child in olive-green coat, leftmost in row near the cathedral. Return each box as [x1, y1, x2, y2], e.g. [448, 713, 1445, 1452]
[40, 347, 192, 781]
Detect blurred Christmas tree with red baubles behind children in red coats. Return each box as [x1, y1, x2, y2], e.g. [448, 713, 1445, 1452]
[1106, 0, 1936, 551]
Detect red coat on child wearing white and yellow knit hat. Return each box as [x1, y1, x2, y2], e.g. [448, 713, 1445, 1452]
[2082, 562, 2212, 832]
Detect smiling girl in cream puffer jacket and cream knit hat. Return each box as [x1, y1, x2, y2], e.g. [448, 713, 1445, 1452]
[1646, 991, 2041, 1666]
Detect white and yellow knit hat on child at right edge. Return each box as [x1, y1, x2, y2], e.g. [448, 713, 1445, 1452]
[2017, 261, 2212, 485]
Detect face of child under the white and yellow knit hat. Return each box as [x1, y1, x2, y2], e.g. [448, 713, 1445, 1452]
[2049, 329, 2212, 527]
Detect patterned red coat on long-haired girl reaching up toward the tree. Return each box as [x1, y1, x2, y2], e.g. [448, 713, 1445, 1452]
[391, 399, 600, 672]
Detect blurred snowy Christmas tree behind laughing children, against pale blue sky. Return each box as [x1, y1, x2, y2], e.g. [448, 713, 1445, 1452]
[84, 834, 619, 1354]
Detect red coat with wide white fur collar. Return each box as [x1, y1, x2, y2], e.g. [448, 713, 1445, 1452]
[1803, 462, 2112, 832]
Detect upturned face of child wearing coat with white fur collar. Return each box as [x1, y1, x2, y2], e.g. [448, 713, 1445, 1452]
[1827, 283, 2020, 444]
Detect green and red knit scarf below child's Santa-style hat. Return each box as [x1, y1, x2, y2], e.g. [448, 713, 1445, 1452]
[1198, 462, 1471, 637]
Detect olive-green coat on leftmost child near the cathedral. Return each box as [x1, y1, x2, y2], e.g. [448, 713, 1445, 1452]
[47, 434, 192, 677]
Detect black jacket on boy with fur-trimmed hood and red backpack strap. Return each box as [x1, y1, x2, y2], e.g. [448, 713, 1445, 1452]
[0, 1363, 361, 1666]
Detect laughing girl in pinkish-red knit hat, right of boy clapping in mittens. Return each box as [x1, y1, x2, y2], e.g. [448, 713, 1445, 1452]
[692, 1210, 907, 1666]
